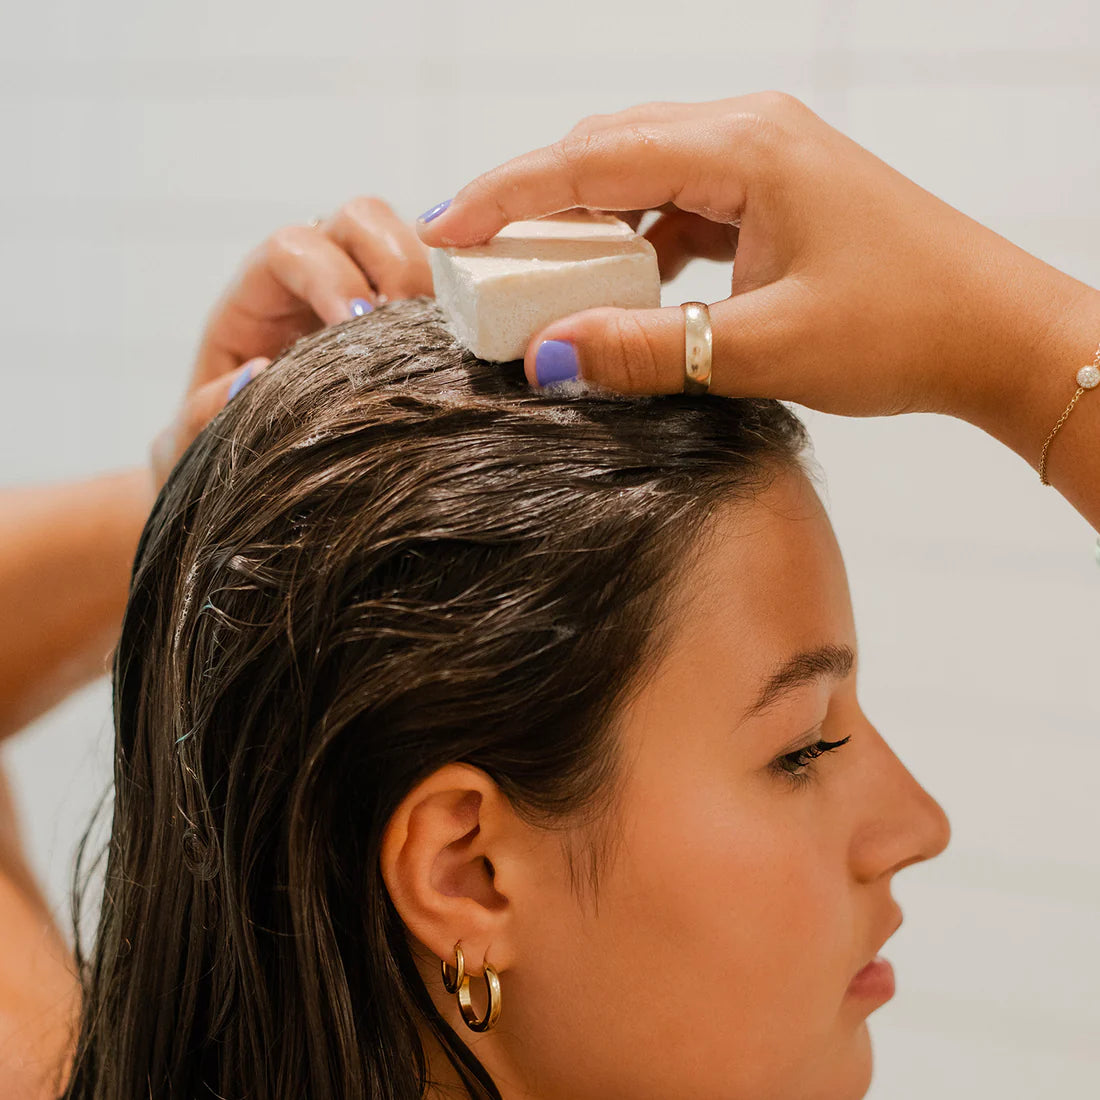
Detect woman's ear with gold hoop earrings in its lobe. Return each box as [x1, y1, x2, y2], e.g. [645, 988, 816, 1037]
[381, 763, 528, 975]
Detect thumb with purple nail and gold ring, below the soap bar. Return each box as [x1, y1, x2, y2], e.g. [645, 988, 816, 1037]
[524, 279, 801, 400]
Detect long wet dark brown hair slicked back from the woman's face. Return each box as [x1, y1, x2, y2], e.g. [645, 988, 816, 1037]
[64, 299, 806, 1100]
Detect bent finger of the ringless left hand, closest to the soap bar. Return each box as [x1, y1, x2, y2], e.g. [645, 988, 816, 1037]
[320, 196, 432, 298]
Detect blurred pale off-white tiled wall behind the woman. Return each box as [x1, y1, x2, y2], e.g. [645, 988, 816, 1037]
[0, 0, 1100, 1100]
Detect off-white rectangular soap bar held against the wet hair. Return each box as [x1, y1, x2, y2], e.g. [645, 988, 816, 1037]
[430, 212, 661, 363]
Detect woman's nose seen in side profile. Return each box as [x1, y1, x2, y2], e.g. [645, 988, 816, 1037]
[851, 728, 952, 881]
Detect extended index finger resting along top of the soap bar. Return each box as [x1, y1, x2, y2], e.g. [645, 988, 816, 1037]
[417, 113, 761, 246]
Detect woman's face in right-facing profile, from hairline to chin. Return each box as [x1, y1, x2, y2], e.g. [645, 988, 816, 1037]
[486, 473, 949, 1100]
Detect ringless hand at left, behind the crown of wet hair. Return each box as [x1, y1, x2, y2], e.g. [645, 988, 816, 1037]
[152, 198, 432, 488]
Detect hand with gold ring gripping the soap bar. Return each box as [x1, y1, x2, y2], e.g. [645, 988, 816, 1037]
[417, 92, 1082, 418]
